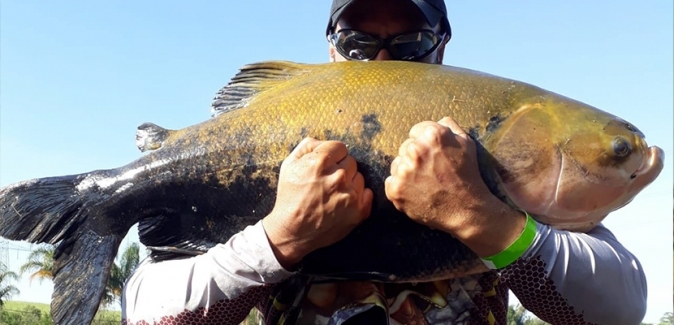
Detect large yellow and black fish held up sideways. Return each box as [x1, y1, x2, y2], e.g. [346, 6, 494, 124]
[0, 62, 664, 324]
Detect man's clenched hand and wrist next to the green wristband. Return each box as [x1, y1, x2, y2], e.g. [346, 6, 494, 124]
[385, 117, 526, 256]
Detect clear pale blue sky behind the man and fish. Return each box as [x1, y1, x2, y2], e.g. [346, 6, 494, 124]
[0, 0, 674, 322]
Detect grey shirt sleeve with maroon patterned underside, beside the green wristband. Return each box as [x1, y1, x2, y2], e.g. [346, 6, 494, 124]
[501, 223, 647, 324]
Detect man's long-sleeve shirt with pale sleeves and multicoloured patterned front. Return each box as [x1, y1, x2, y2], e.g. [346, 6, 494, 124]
[122, 223, 646, 325]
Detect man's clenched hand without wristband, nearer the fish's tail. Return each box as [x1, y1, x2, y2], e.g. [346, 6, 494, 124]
[262, 138, 372, 268]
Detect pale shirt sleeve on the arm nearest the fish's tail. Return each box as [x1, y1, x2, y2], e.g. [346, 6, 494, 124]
[122, 222, 292, 325]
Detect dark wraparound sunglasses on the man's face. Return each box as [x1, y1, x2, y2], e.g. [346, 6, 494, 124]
[328, 29, 443, 61]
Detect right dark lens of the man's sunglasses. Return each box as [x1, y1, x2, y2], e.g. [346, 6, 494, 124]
[387, 31, 440, 61]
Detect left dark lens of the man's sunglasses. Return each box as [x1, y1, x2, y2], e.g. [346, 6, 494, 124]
[332, 30, 380, 60]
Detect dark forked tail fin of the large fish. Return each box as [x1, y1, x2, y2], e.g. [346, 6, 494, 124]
[0, 174, 124, 324]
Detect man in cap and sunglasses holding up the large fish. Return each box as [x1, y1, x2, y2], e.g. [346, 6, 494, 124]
[117, 0, 646, 324]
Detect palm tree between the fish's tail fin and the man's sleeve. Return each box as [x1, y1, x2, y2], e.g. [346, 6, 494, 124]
[101, 242, 140, 306]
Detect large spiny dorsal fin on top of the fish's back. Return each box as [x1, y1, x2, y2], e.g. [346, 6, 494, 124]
[211, 61, 308, 117]
